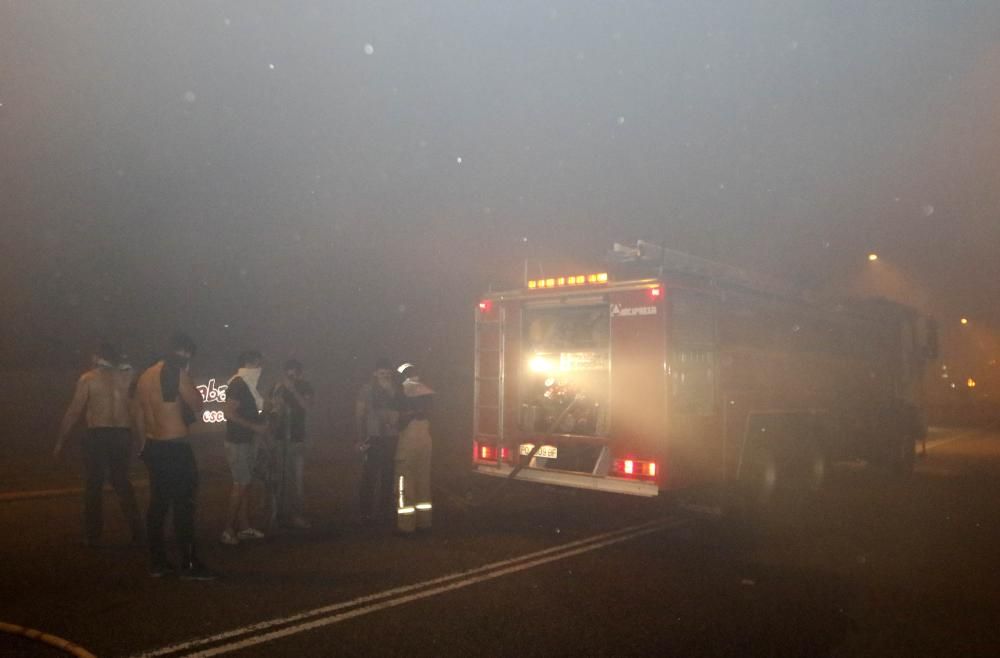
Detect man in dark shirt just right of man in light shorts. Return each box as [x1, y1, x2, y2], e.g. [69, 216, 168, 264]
[268, 359, 313, 528]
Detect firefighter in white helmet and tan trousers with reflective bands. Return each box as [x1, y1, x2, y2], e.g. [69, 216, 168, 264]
[395, 363, 434, 534]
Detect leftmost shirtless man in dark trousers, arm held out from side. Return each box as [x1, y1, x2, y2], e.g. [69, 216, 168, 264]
[53, 343, 143, 546]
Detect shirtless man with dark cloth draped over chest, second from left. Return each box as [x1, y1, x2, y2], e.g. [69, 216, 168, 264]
[136, 334, 215, 580]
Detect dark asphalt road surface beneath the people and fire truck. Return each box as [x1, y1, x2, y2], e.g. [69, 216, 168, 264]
[0, 430, 1000, 656]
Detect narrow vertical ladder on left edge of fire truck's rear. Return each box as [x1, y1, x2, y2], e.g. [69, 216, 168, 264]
[472, 305, 504, 466]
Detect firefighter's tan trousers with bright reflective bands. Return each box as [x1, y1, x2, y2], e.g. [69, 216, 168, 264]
[395, 420, 432, 532]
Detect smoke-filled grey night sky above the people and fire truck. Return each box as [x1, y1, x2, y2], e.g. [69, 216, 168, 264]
[0, 0, 1000, 372]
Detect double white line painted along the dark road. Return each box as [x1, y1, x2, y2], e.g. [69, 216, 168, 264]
[138, 518, 684, 658]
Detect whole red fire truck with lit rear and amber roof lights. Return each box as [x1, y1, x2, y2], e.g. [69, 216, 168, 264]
[472, 242, 937, 502]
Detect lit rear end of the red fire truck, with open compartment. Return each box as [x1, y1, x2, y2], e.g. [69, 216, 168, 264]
[473, 272, 666, 496]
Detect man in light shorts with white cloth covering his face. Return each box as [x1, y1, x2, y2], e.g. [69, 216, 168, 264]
[220, 350, 267, 546]
